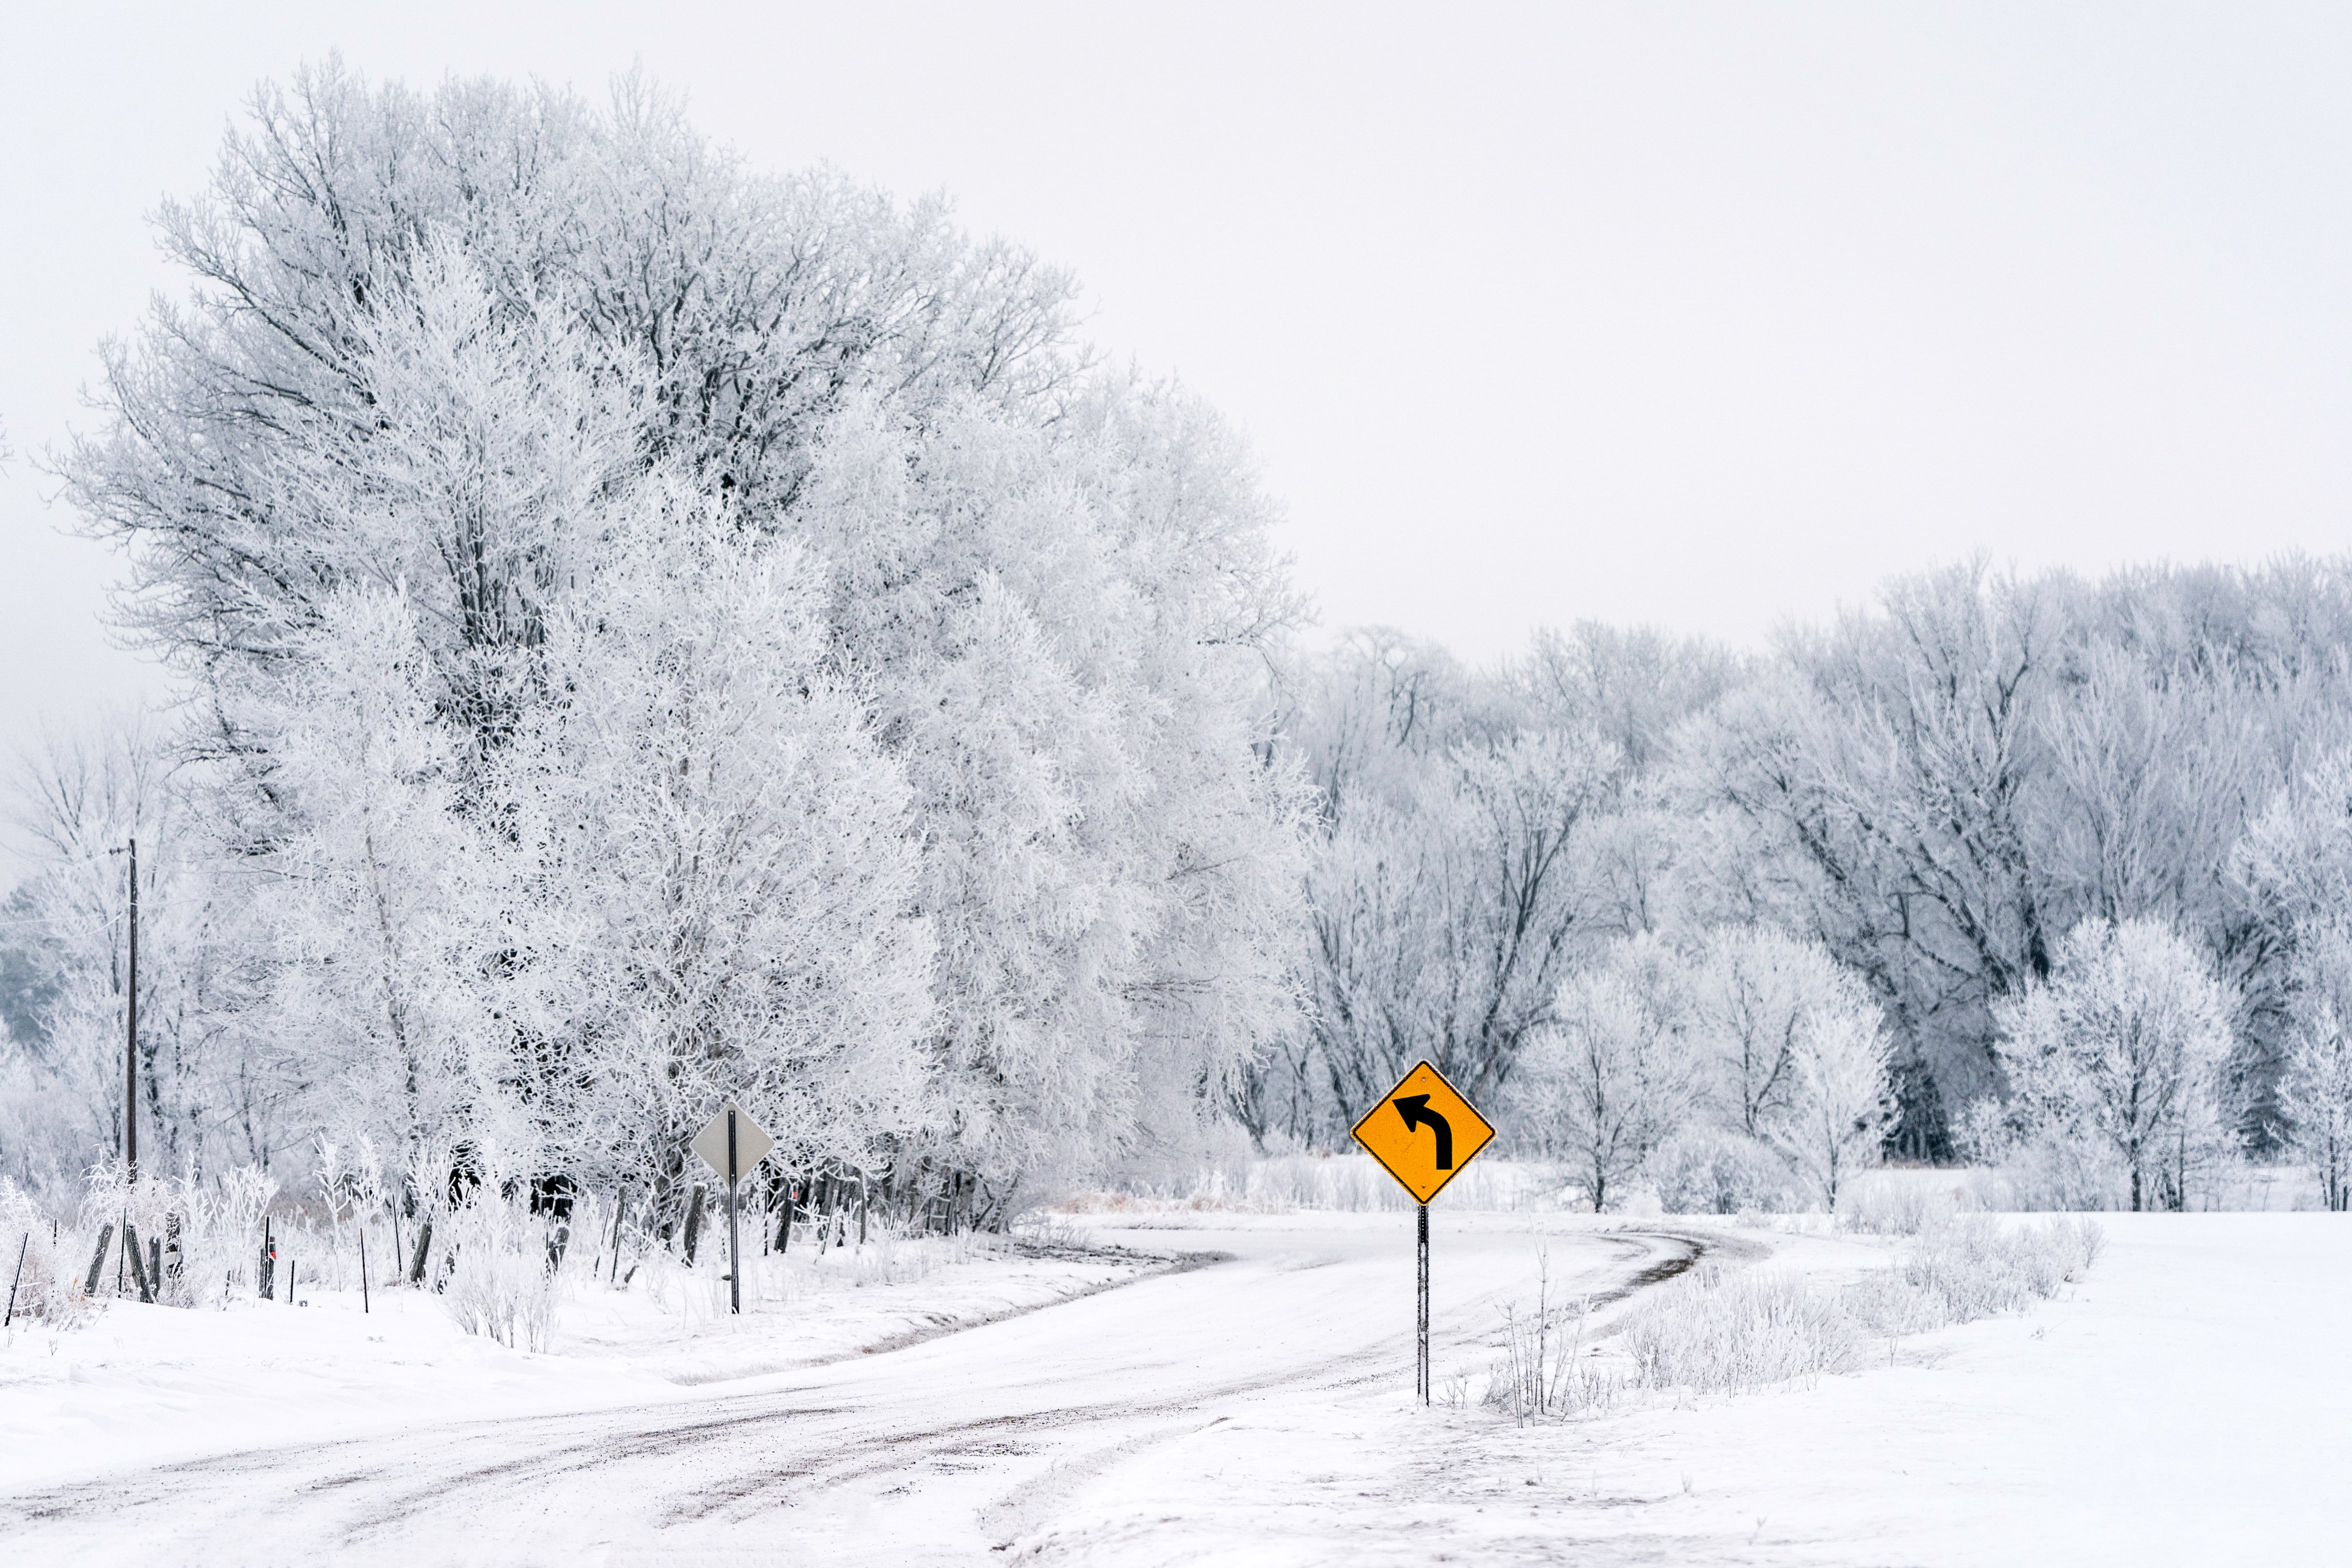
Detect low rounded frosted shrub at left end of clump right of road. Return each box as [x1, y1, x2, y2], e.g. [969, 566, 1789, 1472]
[1623, 1263, 1863, 1394]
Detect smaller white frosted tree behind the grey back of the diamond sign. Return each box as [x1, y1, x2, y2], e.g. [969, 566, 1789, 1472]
[524, 495, 938, 1192]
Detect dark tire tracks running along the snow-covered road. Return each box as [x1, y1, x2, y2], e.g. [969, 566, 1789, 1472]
[0, 1229, 1722, 1561]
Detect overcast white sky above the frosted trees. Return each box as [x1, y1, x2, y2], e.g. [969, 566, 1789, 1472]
[0, 0, 2352, 761]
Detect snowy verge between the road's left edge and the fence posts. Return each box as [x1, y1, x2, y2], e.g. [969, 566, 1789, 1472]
[0, 1237, 1162, 1488]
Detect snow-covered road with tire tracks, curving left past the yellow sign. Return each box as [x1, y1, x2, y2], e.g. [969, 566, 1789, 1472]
[0, 1213, 1696, 1563]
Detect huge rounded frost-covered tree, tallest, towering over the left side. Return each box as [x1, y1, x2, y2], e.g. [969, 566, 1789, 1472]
[66, 66, 1303, 1203]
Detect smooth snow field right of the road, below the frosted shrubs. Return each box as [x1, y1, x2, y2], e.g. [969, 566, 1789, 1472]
[1030, 1213, 2352, 1566]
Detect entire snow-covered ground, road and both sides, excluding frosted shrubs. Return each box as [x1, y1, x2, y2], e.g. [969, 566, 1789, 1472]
[0, 1209, 2352, 1568]
